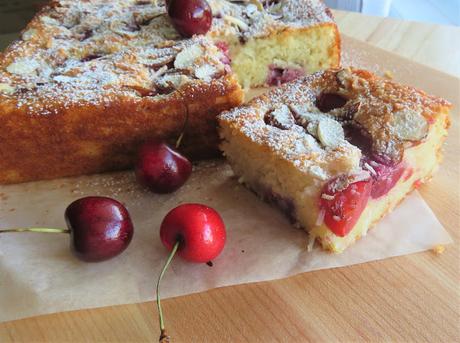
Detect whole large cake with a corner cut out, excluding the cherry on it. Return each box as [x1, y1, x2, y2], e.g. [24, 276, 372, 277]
[0, 0, 340, 184]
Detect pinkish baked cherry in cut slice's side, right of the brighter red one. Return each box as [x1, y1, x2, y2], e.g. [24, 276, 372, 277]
[363, 158, 405, 199]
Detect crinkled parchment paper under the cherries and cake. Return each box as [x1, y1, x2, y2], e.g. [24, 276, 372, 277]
[0, 160, 451, 322]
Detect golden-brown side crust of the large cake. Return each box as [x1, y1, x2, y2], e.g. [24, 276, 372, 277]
[0, 76, 242, 184]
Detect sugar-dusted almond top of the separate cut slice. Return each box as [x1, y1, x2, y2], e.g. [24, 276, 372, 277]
[219, 68, 450, 180]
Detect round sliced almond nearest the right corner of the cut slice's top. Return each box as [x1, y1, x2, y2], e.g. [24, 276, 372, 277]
[390, 109, 428, 141]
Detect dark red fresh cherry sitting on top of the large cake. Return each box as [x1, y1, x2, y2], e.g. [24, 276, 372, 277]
[167, 0, 212, 38]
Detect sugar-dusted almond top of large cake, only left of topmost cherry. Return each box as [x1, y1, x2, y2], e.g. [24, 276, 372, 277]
[0, 0, 232, 115]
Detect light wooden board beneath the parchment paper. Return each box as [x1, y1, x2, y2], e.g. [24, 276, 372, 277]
[0, 30, 460, 342]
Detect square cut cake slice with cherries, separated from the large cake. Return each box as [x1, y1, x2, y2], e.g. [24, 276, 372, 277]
[219, 69, 451, 252]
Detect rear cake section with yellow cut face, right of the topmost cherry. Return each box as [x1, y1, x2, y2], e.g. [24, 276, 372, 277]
[208, 0, 340, 88]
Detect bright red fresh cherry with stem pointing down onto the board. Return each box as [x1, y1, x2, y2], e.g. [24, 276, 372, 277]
[157, 204, 227, 342]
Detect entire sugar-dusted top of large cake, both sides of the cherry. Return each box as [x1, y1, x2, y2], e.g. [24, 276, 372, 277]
[0, 0, 331, 114]
